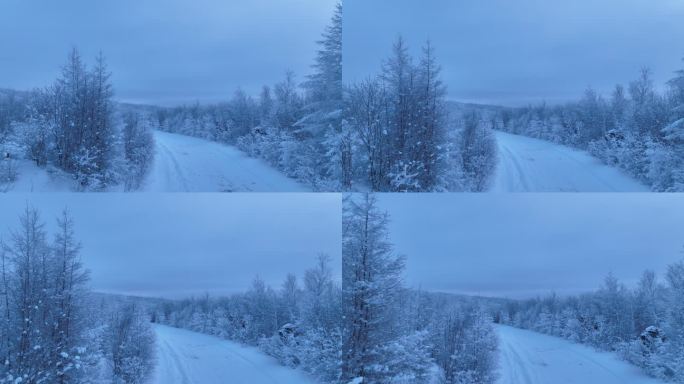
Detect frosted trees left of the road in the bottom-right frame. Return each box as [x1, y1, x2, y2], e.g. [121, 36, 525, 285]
[342, 195, 498, 384]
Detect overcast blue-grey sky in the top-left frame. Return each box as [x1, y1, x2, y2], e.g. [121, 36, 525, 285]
[0, 0, 336, 104]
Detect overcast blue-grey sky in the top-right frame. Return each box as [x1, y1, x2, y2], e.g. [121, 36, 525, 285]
[344, 0, 684, 105]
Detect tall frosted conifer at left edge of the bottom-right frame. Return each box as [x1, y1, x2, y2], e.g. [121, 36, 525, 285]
[342, 194, 410, 383]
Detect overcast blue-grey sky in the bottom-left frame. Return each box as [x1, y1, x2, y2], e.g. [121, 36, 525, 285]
[0, 193, 341, 297]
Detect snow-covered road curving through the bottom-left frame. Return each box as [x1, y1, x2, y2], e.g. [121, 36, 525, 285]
[151, 324, 312, 384]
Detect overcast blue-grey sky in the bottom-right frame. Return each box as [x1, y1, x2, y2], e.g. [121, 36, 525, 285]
[379, 193, 684, 298]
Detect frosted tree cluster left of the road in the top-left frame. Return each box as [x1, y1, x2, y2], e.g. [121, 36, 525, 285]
[0, 48, 154, 191]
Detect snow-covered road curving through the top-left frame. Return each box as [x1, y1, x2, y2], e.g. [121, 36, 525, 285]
[142, 131, 306, 192]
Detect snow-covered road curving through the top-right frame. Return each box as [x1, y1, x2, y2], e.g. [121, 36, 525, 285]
[491, 131, 649, 192]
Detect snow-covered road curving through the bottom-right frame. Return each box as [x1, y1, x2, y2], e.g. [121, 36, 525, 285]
[496, 326, 661, 384]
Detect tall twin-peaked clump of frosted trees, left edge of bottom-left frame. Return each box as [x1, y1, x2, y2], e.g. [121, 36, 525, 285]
[0, 207, 91, 383]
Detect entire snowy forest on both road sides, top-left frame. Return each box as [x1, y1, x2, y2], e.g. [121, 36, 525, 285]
[0, 4, 342, 191]
